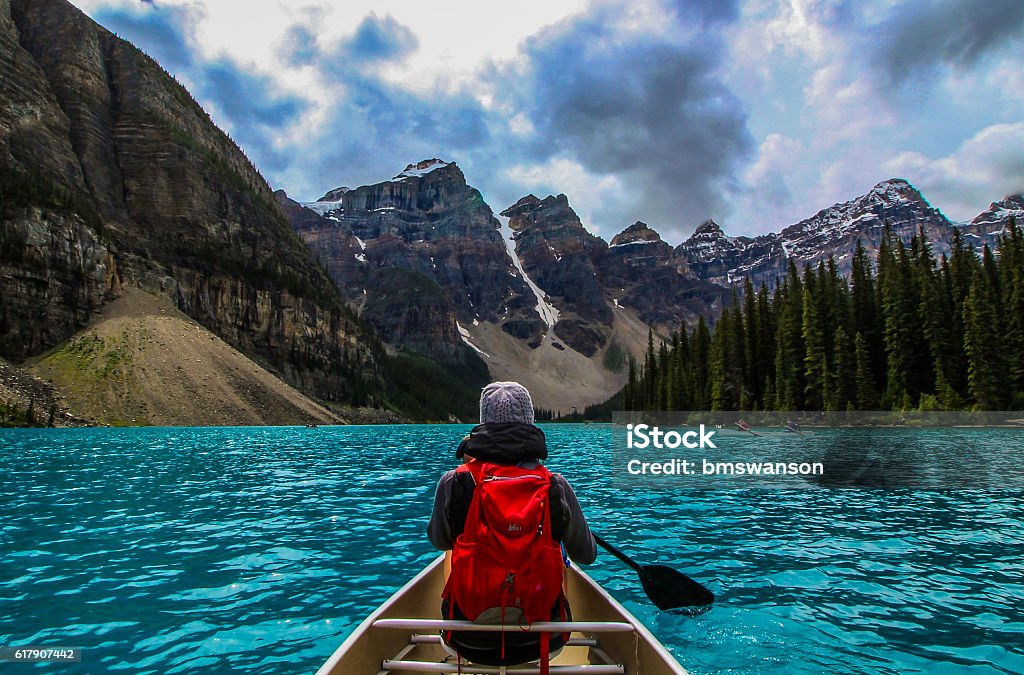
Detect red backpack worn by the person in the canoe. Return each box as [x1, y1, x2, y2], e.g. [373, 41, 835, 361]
[442, 461, 565, 646]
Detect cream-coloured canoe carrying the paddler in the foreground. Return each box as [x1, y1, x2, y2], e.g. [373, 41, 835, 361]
[316, 555, 686, 675]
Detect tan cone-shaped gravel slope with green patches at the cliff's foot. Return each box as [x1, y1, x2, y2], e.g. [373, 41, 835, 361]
[27, 289, 346, 426]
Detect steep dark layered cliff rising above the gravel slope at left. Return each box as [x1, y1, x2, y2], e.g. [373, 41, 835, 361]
[0, 0, 375, 399]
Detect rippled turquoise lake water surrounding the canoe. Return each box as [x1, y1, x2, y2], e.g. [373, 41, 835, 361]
[0, 425, 1024, 674]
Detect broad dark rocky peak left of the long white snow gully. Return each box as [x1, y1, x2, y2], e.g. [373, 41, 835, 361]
[292, 159, 541, 361]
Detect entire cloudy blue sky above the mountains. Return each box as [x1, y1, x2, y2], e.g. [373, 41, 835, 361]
[73, 0, 1024, 244]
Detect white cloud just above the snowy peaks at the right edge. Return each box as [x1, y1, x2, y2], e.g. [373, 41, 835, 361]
[886, 122, 1024, 220]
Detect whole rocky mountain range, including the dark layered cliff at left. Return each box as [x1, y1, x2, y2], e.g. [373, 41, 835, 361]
[0, 0, 1024, 423]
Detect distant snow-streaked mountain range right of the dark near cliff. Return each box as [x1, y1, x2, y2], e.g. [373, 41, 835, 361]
[278, 159, 1024, 412]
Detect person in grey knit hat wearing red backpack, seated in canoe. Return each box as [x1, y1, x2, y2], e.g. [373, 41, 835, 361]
[427, 382, 597, 666]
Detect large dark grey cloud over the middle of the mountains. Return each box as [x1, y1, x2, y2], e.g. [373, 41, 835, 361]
[509, 3, 753, 236]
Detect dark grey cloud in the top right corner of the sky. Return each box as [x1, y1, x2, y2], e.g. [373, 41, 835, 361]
[876, 0, 1024, 83]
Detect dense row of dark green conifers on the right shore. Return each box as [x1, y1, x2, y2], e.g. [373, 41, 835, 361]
[623, 219, 1024, 411]
